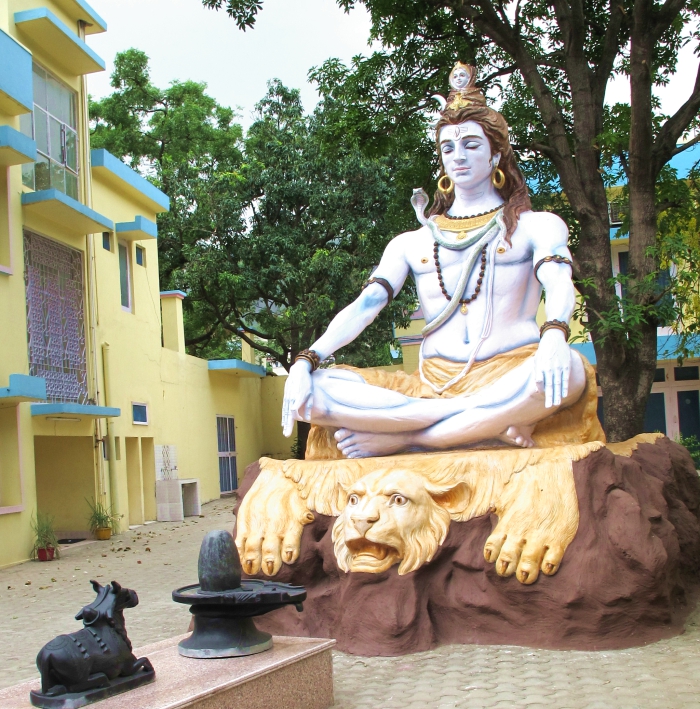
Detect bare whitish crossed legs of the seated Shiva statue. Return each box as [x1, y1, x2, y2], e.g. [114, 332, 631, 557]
[311, 352, 586, 458]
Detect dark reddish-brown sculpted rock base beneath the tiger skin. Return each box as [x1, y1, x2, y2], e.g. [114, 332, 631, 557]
[239, 438, 700, 655]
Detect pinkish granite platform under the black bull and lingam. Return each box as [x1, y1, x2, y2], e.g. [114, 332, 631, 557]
[0, 635, 335, 709]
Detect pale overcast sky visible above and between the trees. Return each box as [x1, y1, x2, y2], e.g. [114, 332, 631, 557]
[87, 0, 698, 127]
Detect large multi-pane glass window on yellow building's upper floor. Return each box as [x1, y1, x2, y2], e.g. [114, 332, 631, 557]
[20, 64, 78, 199]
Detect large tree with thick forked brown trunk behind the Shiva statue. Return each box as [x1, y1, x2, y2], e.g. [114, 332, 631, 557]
[203, 0, 700, 441]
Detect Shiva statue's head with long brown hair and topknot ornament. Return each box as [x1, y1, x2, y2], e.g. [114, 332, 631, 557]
[430, 62, 531, 240]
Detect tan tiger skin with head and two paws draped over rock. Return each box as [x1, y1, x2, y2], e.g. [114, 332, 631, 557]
[236, 441, 603, 584]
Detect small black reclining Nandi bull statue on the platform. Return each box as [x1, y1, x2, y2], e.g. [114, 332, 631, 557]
[30, 581, 155, 709]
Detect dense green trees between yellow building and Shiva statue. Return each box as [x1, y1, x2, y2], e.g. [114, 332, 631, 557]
[91, 49, 415, 368]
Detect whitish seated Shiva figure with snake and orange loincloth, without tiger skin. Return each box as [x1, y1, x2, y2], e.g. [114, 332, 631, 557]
[282, 62, 590, 458]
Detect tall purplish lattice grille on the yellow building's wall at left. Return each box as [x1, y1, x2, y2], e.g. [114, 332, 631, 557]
[24, 232, 88, 404]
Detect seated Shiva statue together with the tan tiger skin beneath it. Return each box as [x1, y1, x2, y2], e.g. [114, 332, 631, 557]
[236, 62, 605, 584]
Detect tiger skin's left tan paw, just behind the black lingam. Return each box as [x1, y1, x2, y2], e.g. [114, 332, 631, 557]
[236, 467, 314, 576]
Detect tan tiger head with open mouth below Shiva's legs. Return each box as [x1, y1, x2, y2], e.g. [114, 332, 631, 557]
[333, 469, 469, 575]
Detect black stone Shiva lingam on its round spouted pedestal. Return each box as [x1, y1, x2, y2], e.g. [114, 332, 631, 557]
[173, 530, 306, 658]
